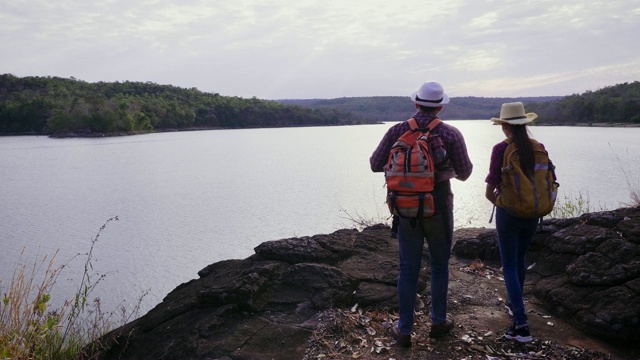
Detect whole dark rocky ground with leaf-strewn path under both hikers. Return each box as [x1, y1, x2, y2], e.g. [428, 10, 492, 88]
[94, 208, 640, 360]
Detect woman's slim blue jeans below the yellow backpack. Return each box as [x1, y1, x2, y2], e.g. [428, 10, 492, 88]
[496, 207, 539, 327]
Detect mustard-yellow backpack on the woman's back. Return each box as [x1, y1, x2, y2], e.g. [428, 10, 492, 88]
[496, 139, 559, 218]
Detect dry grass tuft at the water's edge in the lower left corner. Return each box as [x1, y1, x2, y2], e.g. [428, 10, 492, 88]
[0, 217, 144, 359]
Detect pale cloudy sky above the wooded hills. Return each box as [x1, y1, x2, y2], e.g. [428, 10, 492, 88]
[0, 0, 640, 99]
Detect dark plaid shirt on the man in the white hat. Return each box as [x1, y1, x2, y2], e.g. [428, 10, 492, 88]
[369, 111, 473, 181]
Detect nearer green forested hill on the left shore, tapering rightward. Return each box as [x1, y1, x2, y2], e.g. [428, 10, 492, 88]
[0, 74, 373, 136]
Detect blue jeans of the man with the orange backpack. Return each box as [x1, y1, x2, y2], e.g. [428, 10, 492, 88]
[398, 193, 453, 334]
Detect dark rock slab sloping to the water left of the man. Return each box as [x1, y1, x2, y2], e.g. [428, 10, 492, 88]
[92, 225, 426, 359]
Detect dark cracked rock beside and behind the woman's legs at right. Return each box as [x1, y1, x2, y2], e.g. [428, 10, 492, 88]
[454, 207, 640, 343]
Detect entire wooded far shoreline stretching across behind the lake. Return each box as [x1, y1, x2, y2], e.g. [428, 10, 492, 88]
[0, 74, 640, 136]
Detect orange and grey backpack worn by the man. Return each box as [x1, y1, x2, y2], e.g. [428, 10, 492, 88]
[384, 118, 444, 218]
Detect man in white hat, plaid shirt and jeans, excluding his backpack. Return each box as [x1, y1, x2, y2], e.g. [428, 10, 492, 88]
[369, 82, 473, 347]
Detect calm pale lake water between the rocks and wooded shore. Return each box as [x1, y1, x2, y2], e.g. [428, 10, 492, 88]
[0, 120, 640, 313]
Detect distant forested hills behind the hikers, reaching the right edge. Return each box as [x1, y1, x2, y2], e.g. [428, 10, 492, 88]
[280, 81, 640, 125]
